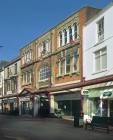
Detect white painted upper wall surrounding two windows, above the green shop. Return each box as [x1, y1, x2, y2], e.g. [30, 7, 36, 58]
[83, 3, 113, 80]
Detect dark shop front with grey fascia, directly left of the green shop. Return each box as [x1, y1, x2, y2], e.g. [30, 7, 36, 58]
[51, 91, 82, 118]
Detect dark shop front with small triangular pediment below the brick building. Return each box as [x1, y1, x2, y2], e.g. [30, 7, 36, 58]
[19, 89, 50, 117]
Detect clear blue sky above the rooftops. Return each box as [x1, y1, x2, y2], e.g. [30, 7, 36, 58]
[0, 0, 112, 61]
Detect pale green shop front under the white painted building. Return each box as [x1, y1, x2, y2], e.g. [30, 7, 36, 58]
[82, 87, 113, 120]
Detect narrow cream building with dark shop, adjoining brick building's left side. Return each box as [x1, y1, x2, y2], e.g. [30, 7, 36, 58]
[2, 57, 21, 114]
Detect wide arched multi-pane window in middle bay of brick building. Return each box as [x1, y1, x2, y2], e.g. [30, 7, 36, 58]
[39, 64, 49, 81]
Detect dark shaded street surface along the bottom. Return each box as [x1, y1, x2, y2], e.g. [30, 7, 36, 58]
[0, 115, 113, 140]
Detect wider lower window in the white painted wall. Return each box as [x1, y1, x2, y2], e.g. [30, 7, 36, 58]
[95, 48, 107, 72]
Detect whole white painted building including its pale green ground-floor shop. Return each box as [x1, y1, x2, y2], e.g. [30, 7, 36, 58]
[83, 2, 113, 121]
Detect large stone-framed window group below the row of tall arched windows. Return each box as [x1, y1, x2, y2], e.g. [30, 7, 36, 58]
[57, 47, 79, 76]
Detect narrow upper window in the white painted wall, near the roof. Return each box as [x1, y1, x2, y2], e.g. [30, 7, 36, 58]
[97, 18, 104, 41]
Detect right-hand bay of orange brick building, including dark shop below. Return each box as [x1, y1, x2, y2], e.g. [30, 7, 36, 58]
[50, 7, 99, 118]
